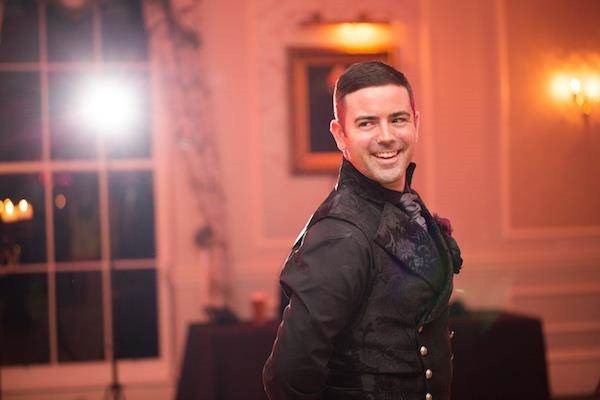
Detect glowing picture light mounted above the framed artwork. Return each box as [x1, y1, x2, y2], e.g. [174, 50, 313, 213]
[301, 13, 398, 54]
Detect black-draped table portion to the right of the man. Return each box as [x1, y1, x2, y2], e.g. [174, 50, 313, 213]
[450, 311, 550, 400]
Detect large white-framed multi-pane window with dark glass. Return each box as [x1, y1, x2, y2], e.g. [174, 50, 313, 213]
[0, 0, 160, 376]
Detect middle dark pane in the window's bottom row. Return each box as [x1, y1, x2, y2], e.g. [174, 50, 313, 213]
[56, 271, 104, 361]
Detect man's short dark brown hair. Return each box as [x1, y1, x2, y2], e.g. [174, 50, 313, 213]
[333, 61, 415, 125]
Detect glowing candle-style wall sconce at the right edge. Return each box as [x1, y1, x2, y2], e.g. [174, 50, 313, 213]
[552, 74, 600, 121]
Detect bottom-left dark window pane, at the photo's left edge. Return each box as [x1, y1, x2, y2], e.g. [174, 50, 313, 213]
[0, 274, 50, 365]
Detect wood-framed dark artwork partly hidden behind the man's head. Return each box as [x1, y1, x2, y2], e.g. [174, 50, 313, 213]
[288, 48, 391, 173]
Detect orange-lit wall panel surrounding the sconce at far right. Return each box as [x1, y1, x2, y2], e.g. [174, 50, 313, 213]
[506, 1, 600, 229]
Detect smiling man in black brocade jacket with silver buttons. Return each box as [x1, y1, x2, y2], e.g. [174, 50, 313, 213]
[263, 62, 462, 400]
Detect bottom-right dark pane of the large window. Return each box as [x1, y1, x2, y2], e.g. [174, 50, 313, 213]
[112, 269, 158, 358]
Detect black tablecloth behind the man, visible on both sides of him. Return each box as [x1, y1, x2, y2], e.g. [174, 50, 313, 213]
[177, 311, 549, 400]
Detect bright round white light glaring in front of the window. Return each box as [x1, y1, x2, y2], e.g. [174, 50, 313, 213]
[78, 78, 139, 134]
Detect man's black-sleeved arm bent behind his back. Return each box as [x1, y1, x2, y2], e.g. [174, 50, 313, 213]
[263, 218, 370, 400]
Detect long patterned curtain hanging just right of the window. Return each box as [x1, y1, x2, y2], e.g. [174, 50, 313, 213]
[143, 0, 230, 307]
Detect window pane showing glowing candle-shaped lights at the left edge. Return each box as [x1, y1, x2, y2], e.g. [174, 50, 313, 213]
[0, 174, 46, 265]
